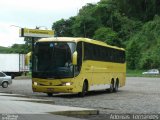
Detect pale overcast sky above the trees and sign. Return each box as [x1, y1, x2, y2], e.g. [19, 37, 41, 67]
[0, 0, 100, 47]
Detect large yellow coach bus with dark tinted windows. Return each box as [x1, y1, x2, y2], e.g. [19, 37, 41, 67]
[32, 37, 126, 96]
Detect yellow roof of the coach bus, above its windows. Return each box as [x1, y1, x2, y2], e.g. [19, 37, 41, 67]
[38, 37, 124, 50]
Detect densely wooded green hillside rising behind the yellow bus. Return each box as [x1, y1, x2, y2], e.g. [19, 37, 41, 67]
[52, 0, 160, 69]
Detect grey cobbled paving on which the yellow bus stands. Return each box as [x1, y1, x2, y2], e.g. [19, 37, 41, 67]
[0, 77, 160, 120]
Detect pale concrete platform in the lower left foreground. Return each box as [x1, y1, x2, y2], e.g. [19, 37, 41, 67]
[0, 93, 98, 120]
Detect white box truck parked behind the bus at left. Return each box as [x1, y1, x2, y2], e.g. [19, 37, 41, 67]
[0, 53, 29, 78]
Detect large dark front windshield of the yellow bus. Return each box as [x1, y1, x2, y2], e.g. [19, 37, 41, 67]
[32, 42, 76, 79]
